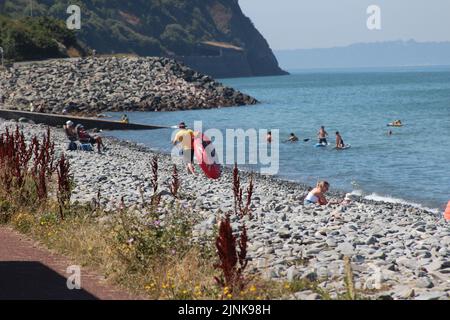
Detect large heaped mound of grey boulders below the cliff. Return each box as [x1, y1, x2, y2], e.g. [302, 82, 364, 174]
[0, 57, 258, 115]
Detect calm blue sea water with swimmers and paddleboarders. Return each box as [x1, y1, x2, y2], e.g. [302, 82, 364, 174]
[108, 69, 450, 208]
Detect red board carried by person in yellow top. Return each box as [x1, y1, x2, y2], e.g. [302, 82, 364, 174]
[194, 133, 222, 179]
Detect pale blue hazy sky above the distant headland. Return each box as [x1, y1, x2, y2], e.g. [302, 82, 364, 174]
[239, 0, 450, 50]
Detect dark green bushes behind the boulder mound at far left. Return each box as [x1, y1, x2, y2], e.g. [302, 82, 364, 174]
[0, 15, 84, 61]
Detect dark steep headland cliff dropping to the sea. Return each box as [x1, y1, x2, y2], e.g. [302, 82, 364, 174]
[2, 0, 285, 76]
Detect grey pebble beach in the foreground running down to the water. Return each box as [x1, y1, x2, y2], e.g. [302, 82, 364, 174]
[0, 120, 450, 300]
